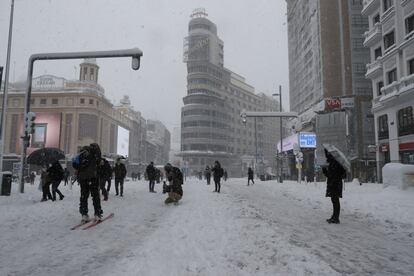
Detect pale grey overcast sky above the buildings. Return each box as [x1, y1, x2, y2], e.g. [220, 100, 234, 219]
[0, 0, 289, 130]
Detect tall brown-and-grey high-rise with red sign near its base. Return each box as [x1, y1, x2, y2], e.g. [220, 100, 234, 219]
[287, 0, 375, 180]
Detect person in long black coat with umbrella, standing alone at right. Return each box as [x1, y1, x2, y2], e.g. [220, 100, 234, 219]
[322, 150, 346, 224]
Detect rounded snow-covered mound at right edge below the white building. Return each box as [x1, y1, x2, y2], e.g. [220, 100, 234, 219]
[382, 163, 414, 189]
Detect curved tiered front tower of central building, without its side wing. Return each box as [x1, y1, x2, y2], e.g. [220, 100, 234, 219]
[181, 13, 232, 171]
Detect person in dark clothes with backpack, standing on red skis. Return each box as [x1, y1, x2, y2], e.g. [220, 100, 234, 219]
[72, 143, 103, 222]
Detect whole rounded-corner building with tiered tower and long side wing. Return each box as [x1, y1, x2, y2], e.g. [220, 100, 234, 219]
[180, 9, 277, 176]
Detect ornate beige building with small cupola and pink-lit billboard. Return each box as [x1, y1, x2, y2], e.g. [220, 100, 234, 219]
[0, 59, 169, 170]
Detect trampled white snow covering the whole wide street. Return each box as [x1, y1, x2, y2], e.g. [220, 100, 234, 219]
[0, 179, 414, 275]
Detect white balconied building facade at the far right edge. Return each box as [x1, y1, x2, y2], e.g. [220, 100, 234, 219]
[362, 0, 414, 180]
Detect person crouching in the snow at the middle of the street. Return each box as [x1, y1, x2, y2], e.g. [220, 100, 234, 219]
[163, 163, 183, 204]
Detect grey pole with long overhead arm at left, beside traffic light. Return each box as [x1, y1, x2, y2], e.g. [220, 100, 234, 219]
[20, 48, 143, 193]
